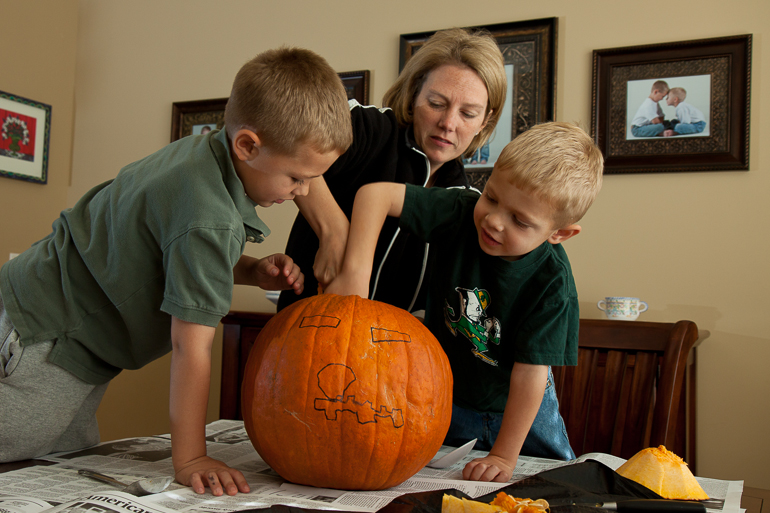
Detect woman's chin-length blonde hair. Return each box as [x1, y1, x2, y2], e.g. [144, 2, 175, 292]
[382, 28, 508, 157]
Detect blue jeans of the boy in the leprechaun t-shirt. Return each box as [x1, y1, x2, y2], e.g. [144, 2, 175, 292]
[444, 367, 575, 460]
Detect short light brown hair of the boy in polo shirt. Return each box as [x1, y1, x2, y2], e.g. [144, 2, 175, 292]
[225, 47, 353, 155]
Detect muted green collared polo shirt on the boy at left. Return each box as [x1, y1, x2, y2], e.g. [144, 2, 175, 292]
[0, 130, 270, 384]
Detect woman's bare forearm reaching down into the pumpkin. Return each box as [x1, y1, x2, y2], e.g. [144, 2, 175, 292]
[294, 177, 349, 287]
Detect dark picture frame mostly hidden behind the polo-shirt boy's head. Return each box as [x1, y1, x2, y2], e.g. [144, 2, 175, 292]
[171, 70, 369, 142]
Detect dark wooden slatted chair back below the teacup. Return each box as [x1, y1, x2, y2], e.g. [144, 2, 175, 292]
[553, 319, 699, 469]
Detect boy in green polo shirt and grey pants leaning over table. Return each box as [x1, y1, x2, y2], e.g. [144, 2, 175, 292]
[0, 48, 352, 495]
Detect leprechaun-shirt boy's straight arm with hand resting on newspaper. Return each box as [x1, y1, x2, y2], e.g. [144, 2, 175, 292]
[463, 363, 548, 483]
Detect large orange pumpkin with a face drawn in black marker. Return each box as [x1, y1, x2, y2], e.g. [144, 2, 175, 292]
[241, 294, 452, 490]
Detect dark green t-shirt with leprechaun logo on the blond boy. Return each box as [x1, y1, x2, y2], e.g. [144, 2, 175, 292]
[400, 185, 579, 413]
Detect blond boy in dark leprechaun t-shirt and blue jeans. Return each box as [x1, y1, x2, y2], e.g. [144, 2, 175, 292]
[326, 123, 603, 482]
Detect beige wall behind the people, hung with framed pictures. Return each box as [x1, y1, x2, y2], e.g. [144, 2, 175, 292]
[0, 0, 770, 488]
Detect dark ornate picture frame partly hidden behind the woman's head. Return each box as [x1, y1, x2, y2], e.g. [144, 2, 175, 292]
[399, 18, 558, 188]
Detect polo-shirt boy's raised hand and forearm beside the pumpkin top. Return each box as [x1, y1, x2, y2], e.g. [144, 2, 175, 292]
[233, 253, 305, 294]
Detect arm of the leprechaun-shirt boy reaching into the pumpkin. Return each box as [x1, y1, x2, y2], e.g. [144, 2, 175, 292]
[325, 182, 406, 298]
